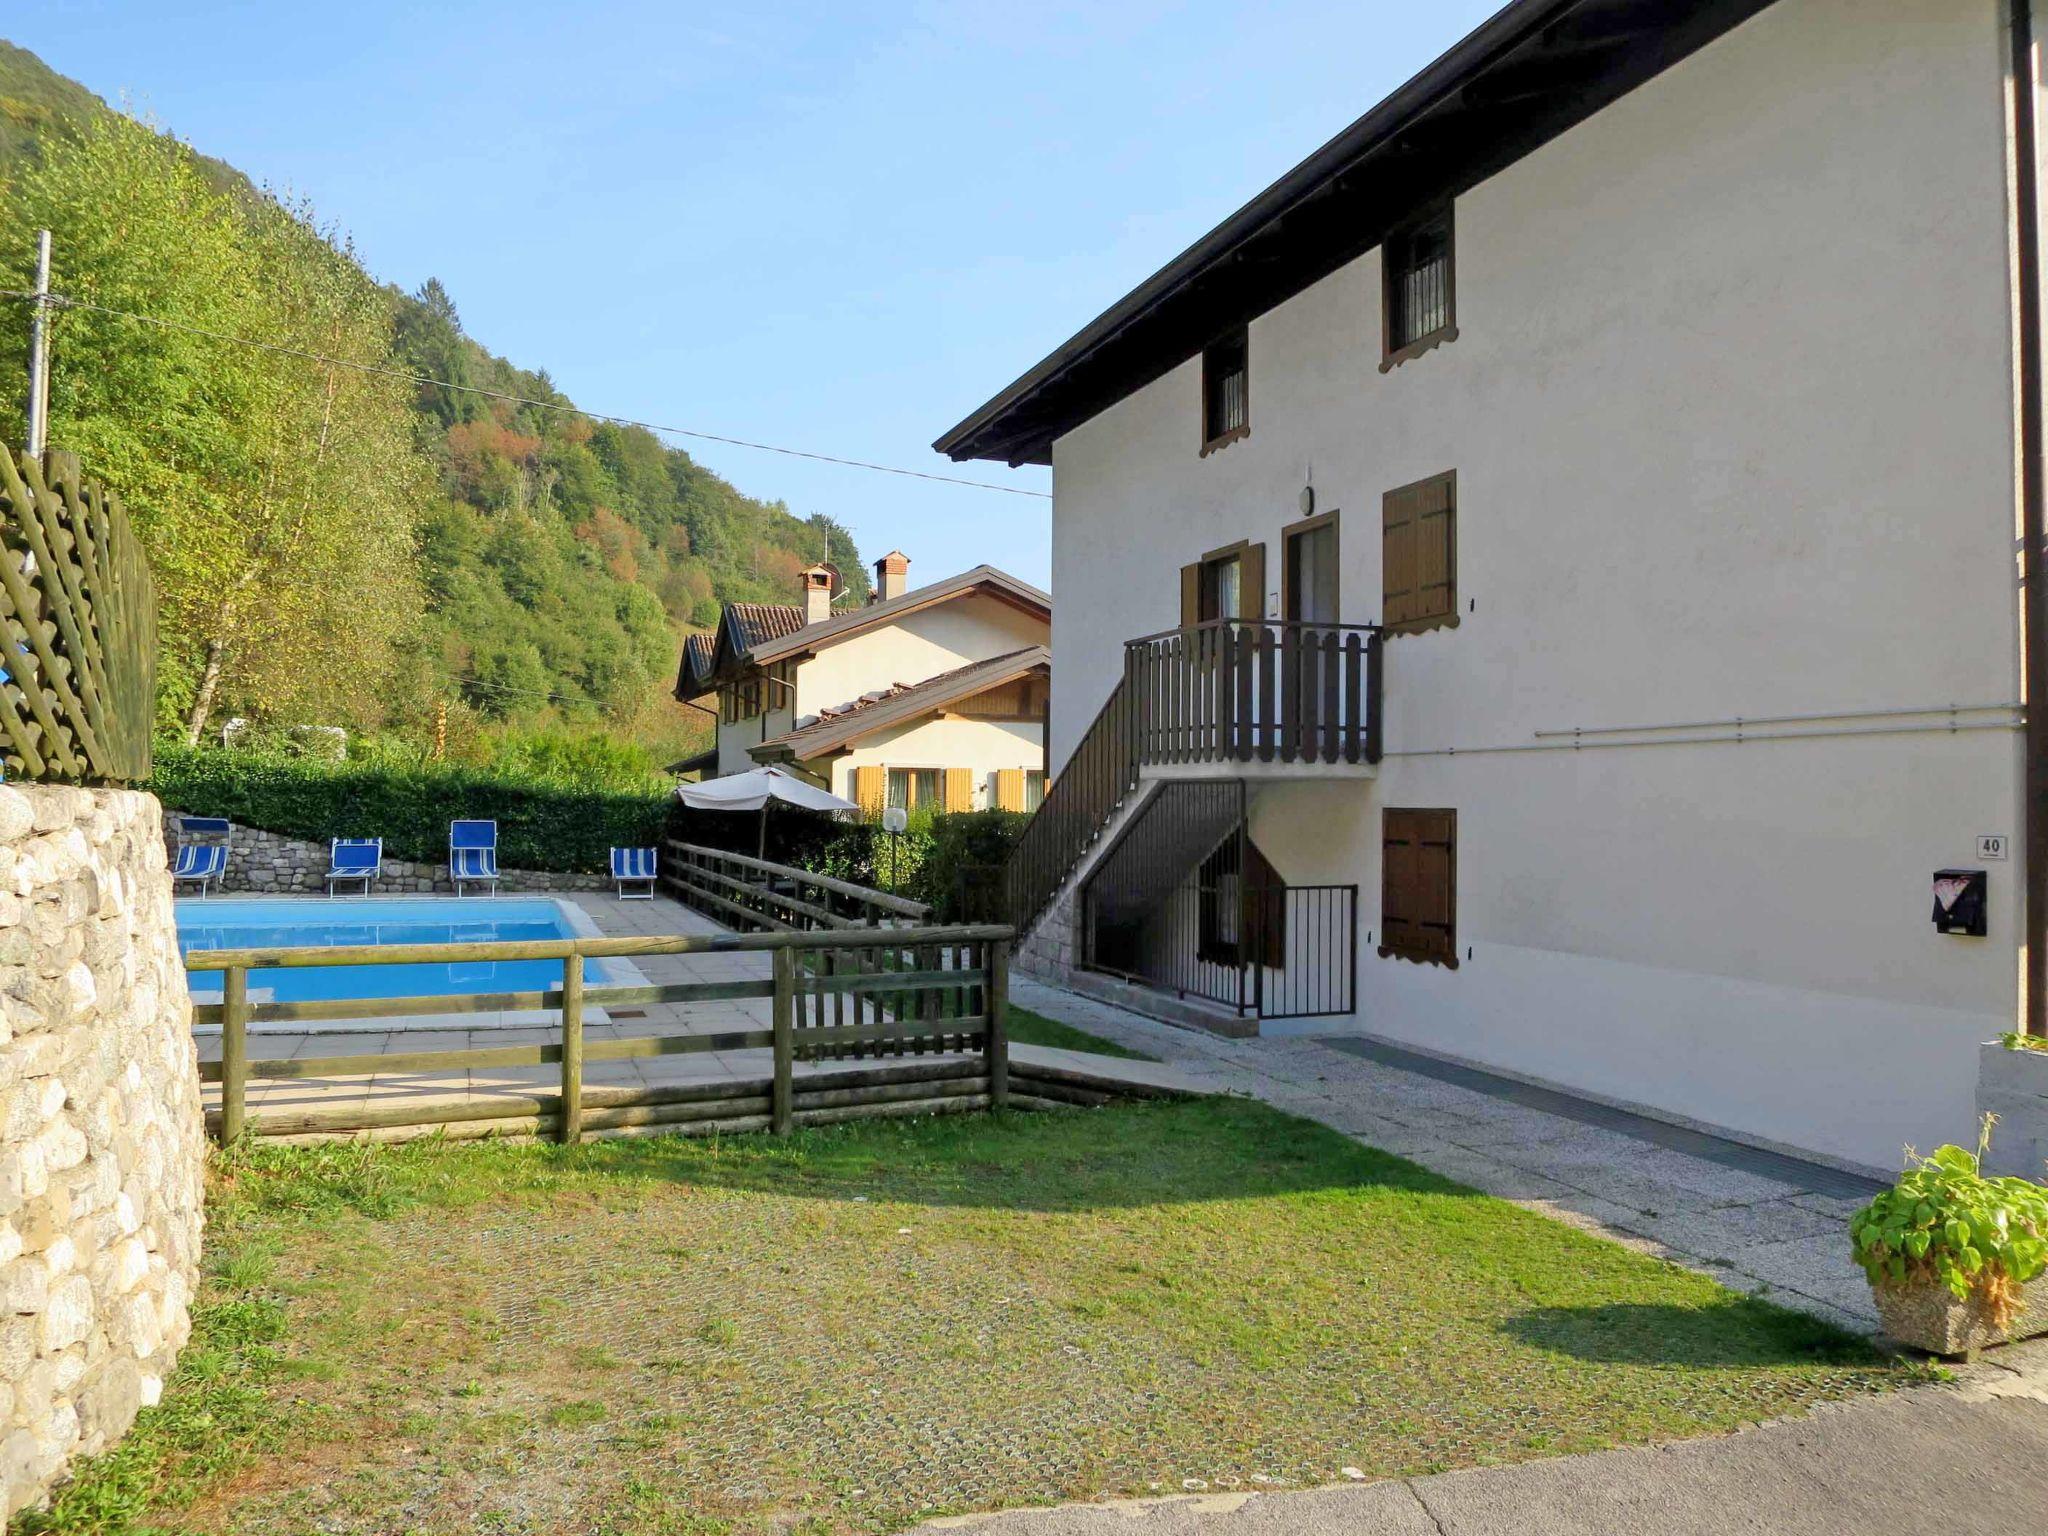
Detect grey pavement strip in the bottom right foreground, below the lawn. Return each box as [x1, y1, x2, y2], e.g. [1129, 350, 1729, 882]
[918, 1339, 2048, 1536]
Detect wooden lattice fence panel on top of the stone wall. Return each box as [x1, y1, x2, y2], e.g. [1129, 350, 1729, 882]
[0, 451, 156, 784]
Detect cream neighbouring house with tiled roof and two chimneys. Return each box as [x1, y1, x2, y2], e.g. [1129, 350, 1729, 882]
[676, 551, 1053, 813]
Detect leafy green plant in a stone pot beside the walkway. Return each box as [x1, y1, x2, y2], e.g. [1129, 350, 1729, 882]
[1849, 1116, 2048, 1356]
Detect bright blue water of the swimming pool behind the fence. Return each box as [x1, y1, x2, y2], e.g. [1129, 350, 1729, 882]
[176, 897, 629, 1001]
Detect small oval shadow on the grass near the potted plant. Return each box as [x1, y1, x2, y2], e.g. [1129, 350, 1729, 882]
[1501, 1296, 1882, 1370]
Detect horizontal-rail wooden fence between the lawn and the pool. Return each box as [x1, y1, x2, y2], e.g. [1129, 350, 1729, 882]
[186, 924, 1015, 1143]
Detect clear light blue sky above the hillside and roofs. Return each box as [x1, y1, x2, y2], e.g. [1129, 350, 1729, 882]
[6, 0, 1495, 584]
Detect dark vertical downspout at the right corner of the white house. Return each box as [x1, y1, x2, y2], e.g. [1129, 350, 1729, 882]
[2011, 0, 2048, 1034]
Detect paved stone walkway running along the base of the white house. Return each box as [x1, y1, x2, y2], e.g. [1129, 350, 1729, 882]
[1012, 977, 1878, 1331]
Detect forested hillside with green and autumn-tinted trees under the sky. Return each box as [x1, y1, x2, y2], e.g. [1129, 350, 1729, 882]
[0, 43, 866, 770]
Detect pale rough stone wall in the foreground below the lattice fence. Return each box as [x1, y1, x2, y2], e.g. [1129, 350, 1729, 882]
[0, 784, 205, 1516]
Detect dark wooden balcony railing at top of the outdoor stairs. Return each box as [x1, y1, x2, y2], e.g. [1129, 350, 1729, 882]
[1122, 618, 1380, 766]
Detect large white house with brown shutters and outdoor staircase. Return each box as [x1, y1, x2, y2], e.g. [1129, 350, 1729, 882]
[938, 0, 2048, 1167]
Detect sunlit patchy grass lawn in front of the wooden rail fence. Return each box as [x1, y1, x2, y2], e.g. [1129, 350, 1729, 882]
[16, 1100, 1909, 1536]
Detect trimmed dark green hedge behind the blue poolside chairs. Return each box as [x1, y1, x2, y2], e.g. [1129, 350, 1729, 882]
[145, 743, 672, 872]
